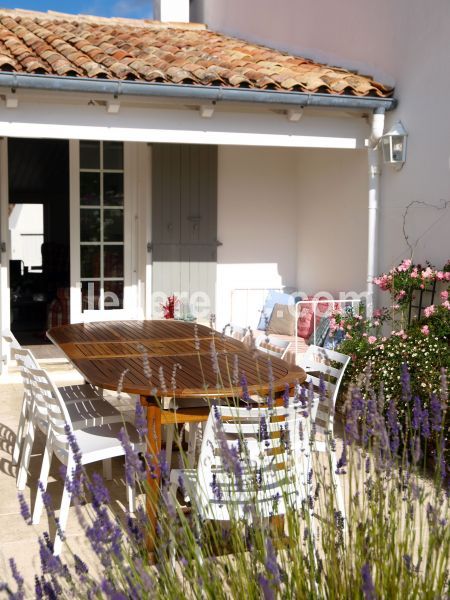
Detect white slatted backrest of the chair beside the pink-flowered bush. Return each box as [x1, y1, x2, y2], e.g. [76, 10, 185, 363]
[300, 346, 350, 433]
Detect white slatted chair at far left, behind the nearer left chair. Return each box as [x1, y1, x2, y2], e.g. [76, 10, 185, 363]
[13, 348, 123, 490]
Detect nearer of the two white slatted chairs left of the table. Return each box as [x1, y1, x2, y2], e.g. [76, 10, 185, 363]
[29, 369, 146, 556]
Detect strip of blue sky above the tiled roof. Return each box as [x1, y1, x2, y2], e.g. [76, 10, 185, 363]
[0, 0, 153, 18]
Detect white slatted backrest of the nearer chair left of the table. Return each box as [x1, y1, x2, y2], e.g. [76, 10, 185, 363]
[28, 368, 72, 452]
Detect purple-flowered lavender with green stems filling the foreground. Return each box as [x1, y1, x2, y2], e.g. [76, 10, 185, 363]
[2, 361, 450, 600]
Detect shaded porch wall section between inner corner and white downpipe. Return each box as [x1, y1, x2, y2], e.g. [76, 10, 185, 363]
[297, 149, 368, 297]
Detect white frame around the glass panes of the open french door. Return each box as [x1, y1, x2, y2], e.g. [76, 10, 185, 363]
[69, 140, 143, 323]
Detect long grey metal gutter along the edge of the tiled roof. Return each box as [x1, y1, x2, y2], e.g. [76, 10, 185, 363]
[0, 72, 397, 111]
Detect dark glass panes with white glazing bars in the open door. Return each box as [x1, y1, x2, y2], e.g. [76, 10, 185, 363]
[79, 141, 125, 312]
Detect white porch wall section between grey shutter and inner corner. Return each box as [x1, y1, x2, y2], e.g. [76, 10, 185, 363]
[216, 146, 299, 326]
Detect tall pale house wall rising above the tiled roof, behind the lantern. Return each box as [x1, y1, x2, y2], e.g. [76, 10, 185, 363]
[199, 0, 450, 269]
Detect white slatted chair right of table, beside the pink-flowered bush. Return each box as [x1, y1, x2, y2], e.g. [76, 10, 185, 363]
[300, 346, 350, 518]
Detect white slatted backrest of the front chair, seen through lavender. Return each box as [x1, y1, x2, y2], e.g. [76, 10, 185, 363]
[193, 398, 309, 520]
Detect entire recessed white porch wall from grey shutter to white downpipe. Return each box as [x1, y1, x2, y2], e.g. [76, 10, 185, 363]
[216, 146, 368, 327]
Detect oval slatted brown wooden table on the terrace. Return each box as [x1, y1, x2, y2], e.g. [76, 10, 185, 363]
[47, 320, 306, 550]
